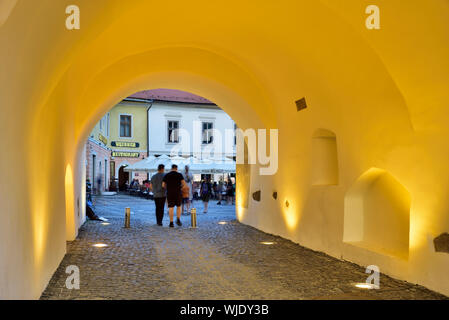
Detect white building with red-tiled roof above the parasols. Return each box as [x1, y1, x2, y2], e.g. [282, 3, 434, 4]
[126, 89, 236, 159]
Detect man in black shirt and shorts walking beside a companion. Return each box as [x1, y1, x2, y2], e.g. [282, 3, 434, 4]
[162, 164, 186, 228]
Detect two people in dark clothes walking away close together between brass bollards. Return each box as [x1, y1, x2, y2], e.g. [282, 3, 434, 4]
[150, 164, 191, 228]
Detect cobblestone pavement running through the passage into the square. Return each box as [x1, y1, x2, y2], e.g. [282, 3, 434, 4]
[41, 195, 445, 300]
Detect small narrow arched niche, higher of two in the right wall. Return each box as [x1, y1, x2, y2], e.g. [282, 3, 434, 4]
[311, 129, 338, 186]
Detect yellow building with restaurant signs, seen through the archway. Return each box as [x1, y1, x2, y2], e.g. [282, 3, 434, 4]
[86, 98, 148, 192]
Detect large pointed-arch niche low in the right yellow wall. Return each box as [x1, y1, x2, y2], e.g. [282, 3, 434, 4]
[343, 168, 411, 259]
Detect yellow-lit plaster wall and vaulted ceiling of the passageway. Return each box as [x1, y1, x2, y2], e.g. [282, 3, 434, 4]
[0, 0, 449, 298]
